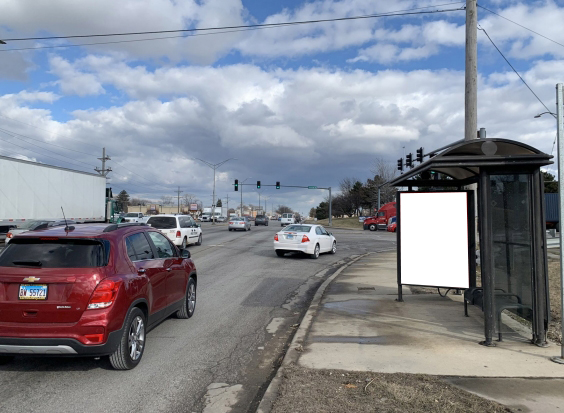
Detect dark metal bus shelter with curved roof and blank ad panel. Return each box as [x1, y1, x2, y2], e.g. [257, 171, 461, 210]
[390, 139, 552, 346]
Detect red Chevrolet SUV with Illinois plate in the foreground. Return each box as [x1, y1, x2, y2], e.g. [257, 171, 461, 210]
[0, 224, 198, 370]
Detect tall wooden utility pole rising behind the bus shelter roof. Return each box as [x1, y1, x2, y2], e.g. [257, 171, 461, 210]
[464, 0, 478, 141]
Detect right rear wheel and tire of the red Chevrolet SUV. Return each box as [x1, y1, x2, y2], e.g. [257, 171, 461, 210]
[109, 307, 147, 370]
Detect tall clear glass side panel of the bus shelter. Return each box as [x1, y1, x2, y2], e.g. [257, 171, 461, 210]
[490, 174, 533, 329]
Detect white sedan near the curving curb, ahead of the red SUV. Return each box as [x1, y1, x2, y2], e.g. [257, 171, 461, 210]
[274, 224, 337, 259]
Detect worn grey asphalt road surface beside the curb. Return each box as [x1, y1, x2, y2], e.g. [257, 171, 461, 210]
[0, 222, 395, 413]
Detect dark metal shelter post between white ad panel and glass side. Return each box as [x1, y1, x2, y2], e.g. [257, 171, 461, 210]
[478, 170, 495, 346]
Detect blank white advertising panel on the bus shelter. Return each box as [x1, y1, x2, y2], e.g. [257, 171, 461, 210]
[399, 192, 469, 288]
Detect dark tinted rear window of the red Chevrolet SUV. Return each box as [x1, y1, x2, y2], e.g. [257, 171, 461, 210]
[0, 238, 109, 268]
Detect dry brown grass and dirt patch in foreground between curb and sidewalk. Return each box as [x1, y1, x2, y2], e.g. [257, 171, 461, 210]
[272, 366, 511, 413]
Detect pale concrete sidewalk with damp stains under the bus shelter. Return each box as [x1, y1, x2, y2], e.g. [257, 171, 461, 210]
[259, 251, 564, 412]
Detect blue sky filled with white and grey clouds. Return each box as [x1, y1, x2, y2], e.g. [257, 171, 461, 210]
[0, 0, 564, 212]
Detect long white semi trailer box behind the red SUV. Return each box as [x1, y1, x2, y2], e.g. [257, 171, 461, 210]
[0, 156, 106, 232]
